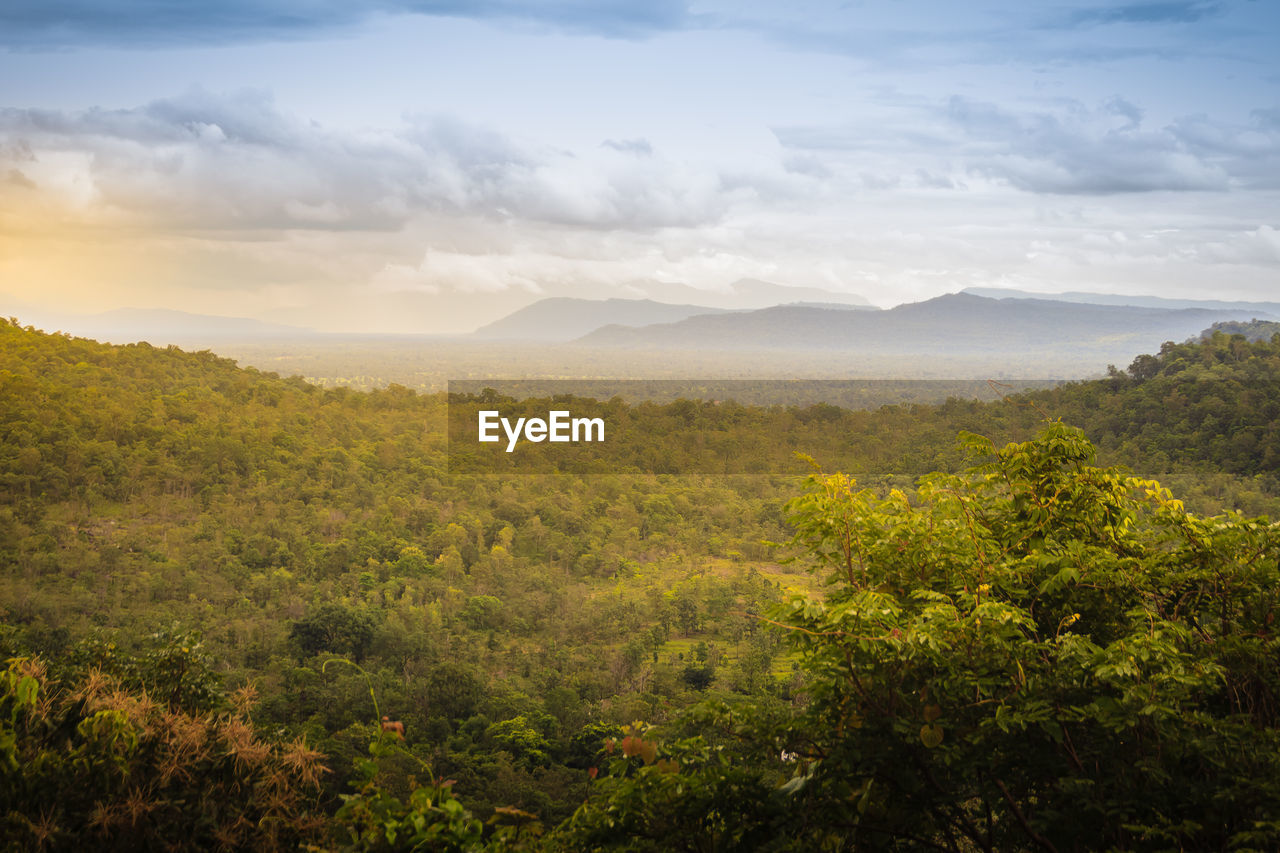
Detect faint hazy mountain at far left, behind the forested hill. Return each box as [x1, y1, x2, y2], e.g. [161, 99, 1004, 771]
[18, 309, 316, 346]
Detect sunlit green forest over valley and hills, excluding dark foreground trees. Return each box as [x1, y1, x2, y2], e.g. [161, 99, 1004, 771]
[0, 315, 1280, 849]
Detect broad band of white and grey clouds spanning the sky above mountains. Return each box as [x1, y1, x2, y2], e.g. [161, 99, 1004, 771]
[0, 81, 1280, 330]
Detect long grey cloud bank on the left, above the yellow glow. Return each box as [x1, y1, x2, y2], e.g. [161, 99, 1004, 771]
[0, 90, 747, 231]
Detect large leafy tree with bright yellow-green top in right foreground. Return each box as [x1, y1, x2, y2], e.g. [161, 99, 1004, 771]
[571, 423, 1280, 850]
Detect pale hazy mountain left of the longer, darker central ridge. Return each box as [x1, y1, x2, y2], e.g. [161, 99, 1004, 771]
[475, 296, 724, 342]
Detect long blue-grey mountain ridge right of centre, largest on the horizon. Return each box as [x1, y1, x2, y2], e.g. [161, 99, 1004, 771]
[579, 293, 1256, 360]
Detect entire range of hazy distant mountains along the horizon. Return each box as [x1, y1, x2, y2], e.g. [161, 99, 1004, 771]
[10, 286, 1280, 364]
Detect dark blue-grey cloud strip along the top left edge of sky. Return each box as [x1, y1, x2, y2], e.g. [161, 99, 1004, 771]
[0, 0, 689, 49]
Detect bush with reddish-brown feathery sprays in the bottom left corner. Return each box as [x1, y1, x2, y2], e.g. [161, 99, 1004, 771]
[0, 640, 328, 850]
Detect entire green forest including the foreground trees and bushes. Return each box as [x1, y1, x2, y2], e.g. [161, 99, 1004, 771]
[0, 319, 1280, 850]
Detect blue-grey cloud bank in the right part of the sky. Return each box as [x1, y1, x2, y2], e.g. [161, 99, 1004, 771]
[773, 95, 1280, 196]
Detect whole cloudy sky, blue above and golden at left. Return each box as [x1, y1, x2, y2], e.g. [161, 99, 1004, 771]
[0, 0, 1280, 333]
